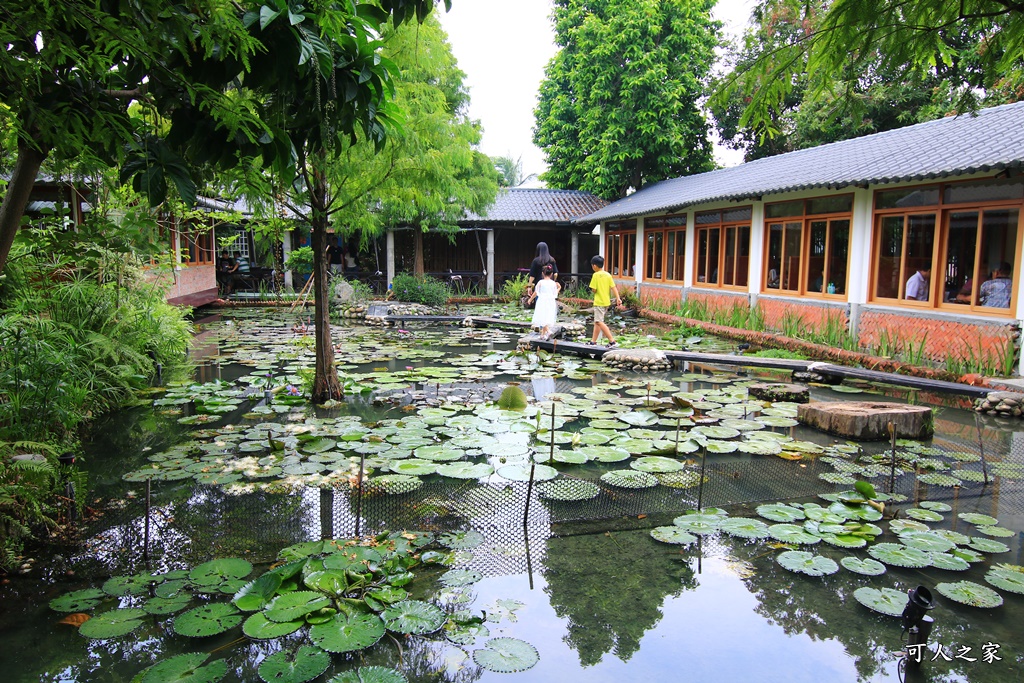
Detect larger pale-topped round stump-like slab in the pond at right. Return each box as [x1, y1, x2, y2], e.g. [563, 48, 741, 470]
[797, 400, 935, 441]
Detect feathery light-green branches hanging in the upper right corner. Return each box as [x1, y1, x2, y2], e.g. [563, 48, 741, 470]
[714, 0, 1024, 141]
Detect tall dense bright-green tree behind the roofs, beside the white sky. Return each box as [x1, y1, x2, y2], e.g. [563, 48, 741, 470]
[534, 0, 719, 200]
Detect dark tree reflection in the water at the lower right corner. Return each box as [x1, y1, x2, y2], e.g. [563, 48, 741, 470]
[736, 544, 1020, 683]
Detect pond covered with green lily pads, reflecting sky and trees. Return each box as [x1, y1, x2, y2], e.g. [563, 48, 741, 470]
[0, 309, 1024, 683]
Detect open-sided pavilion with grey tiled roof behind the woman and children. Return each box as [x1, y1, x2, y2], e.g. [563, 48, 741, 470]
[387, 187, 607, 293]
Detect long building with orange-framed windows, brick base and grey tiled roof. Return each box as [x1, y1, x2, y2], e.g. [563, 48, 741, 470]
[575, 102, 1024, 368]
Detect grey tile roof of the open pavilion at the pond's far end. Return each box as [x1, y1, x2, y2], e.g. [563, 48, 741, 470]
[459, 187, 608, 225]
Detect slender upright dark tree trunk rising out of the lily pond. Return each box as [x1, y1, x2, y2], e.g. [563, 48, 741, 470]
[309, 162, 342, 403]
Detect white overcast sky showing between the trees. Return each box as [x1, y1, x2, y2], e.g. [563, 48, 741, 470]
[437, 0, 755, 187]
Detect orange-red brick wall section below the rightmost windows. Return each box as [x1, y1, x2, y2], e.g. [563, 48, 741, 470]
[857, 309, 1019, 360]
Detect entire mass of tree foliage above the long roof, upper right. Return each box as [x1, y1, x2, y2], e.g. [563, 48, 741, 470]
[712, 0, 1024, 148]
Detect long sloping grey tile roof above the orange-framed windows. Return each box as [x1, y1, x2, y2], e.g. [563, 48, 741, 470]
[574, 101, 1024, 223]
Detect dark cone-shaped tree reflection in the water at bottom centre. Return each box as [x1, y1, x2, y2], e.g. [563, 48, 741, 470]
[544, 530, 697, 667]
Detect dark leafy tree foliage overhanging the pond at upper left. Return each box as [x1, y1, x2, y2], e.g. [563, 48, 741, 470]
[0, 0, 440, 278]
